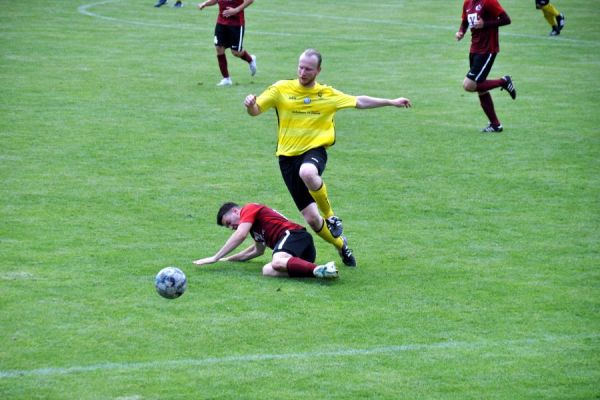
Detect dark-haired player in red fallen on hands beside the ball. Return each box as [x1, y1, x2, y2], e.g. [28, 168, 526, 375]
[194, 203, 338, 279]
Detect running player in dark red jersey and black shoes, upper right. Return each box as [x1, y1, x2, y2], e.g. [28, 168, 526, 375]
[455, 0, 517, 132]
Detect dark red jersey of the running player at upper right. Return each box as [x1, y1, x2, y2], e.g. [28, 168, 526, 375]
[462, 0, 505, 54]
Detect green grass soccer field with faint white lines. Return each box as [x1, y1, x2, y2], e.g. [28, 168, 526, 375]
[0, 0, 600, 400]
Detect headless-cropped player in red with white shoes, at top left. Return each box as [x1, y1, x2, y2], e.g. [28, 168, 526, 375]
[198, 0, 256, 86]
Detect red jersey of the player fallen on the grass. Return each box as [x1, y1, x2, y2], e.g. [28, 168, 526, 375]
[240, 203, 304, 249]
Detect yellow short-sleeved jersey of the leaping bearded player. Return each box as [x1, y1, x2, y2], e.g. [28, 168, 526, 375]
[256, 79, 356, 156]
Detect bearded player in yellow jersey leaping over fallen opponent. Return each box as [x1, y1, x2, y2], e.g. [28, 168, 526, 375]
[244, 49, 411, 266]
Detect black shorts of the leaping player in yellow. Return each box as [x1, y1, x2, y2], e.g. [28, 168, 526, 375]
[279, 147, 327, 211]
